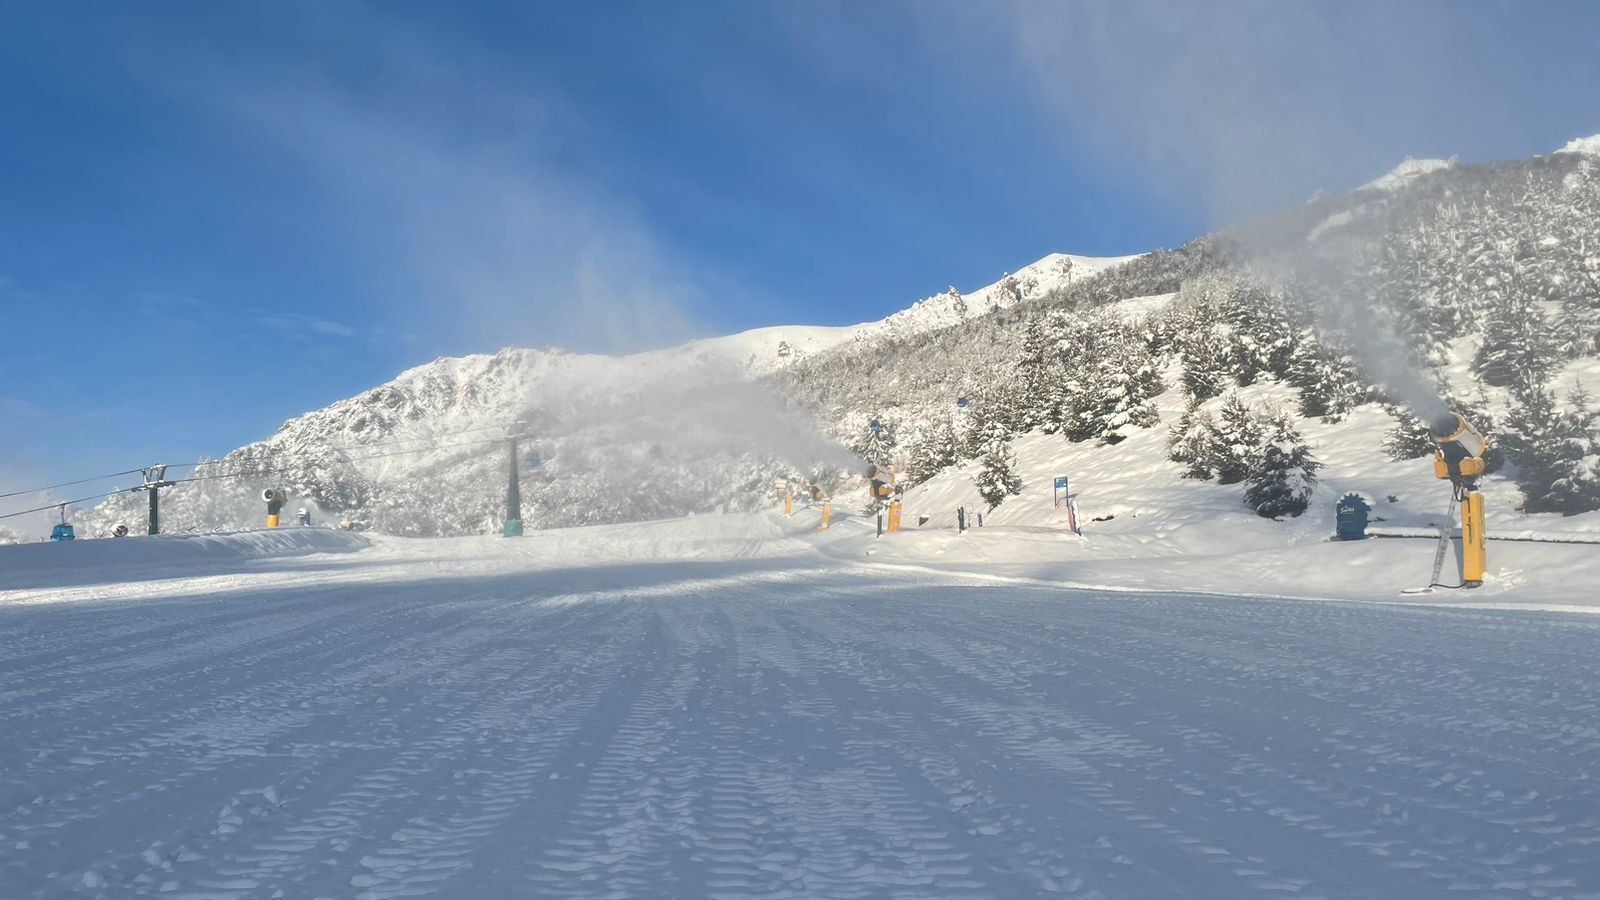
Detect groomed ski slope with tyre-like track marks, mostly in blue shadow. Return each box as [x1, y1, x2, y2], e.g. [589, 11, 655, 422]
[0, 516, 1600, 898]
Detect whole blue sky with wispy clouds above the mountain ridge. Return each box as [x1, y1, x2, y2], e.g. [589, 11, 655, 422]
[0, 0, 1600, 488]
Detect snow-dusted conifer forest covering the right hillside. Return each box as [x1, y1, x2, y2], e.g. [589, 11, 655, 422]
[790, 154, 1600, 516]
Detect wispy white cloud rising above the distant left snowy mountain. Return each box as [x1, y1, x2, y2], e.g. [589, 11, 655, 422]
[148, 16, 714, 351]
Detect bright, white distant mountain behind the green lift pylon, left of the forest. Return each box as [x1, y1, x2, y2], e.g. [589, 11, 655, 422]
[78, 253, 1133, 535]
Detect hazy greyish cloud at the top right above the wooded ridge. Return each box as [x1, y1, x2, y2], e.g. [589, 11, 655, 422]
[918, 0, 1518, 224]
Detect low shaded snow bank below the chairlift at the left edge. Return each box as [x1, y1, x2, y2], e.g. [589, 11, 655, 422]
[0, 528, 370, 589]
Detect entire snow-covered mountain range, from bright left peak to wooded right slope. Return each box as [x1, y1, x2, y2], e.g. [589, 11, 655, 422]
[80, 141, 1600, 535]
